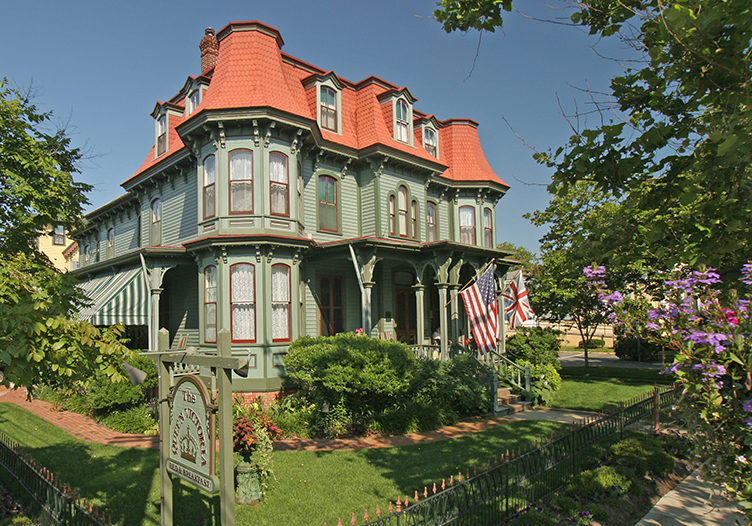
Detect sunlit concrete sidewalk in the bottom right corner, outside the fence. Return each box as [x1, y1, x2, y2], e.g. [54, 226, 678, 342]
[635, 470, 745, 526]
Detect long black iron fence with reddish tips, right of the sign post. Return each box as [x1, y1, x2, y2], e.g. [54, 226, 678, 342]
[356, 386, 679, 526]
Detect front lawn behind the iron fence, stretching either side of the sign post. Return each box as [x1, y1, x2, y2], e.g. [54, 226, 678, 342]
[0, 403, 566, 526]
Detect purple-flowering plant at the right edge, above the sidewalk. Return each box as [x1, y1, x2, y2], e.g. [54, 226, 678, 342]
[584, 264, 752, 520]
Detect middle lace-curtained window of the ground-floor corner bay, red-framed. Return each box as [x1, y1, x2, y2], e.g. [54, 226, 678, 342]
[230, 263, 256, 343]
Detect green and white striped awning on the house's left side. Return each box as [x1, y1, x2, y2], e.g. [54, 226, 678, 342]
[78, 267, 149, 325]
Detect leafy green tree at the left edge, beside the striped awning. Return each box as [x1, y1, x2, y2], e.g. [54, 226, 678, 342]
[0, 80, 132, 393]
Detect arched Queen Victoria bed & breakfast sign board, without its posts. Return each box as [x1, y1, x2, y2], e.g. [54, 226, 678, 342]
[167, 375, 219, 493]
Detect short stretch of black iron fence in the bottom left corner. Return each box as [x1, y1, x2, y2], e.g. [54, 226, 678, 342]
[0, 433, 112, 526]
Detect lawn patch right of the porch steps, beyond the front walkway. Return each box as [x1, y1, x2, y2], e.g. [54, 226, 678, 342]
[548, 367, 671, 411]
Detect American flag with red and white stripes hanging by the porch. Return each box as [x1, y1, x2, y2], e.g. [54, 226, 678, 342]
[462, 264, 499, 355]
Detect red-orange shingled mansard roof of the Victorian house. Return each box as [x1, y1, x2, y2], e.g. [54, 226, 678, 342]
[126, 21, 508, 187]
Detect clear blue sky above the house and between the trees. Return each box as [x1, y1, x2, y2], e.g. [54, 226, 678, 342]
[0, 0, 628, 251]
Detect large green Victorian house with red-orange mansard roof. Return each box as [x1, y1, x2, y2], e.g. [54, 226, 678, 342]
[75, 22, 509, 398]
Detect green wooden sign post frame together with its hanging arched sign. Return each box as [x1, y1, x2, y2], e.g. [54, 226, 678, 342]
[150, 329, 246, 526]
